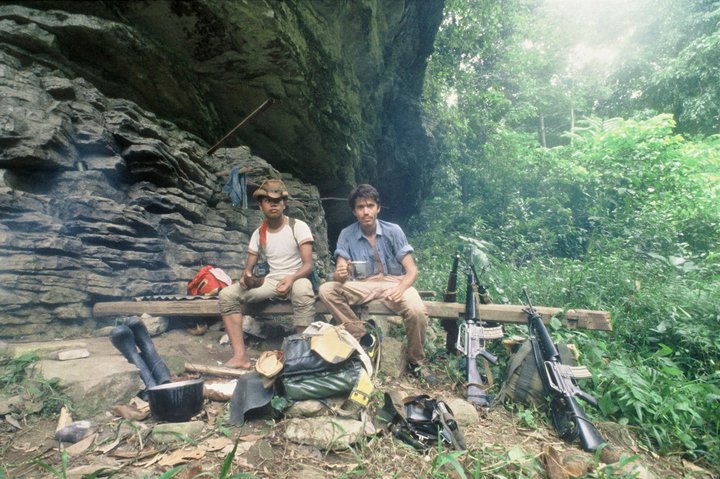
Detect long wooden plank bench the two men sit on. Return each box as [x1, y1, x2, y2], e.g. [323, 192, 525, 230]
[92, 298, 612, 331]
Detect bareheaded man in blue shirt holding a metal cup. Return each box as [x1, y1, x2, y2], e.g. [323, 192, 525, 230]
[318, 184, 438, 385]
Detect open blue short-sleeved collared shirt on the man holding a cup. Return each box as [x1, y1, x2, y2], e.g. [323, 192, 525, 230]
[334, 220, 413, 276]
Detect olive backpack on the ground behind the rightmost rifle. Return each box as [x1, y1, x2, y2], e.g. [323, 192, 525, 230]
[495, 340, 577, 409]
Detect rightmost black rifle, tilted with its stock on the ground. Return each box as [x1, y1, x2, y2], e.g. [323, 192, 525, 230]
[523, 288, 605, 452]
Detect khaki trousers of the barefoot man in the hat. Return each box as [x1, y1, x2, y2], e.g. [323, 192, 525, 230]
[219, 277, 315, 326]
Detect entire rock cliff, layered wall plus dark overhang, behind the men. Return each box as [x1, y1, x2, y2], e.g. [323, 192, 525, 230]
[0, 0, 442, 337]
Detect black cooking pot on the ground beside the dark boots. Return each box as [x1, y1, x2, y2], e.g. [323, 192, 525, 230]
[148, 379, 204, 422]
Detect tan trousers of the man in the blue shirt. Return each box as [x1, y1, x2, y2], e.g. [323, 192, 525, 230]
[318, 276, 428, 364]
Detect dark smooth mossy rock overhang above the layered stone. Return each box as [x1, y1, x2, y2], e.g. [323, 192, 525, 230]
[0, 0, 443, 236]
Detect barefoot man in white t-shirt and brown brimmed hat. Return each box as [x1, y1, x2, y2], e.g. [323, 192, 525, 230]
[219, 179, 315, 369]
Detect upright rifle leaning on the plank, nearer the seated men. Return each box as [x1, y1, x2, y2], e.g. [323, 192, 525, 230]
[457, 253, 503, 407]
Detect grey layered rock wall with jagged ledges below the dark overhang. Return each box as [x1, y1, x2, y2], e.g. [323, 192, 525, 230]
[0, 57, 328, 337]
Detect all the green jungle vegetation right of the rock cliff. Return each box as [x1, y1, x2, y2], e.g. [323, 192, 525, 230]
[409, 0, 720, 467]
